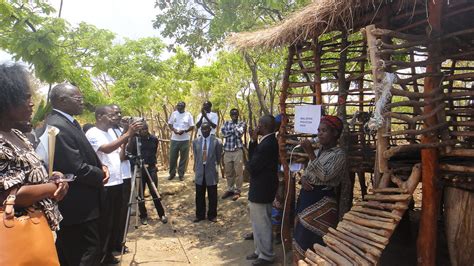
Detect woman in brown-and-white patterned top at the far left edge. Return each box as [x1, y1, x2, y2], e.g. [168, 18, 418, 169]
[0, 64, 68, 243]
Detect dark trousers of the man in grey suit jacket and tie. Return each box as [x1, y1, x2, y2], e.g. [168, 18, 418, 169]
[196, 167, 217, 219]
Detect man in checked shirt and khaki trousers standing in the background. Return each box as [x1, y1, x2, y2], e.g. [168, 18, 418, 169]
[221, 108, 247, 201]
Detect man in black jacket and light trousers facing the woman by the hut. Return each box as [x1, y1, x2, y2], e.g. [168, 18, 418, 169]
[247, 115, 278, 265]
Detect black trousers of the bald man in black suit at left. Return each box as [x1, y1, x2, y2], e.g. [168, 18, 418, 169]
[56, 219, 102, 266]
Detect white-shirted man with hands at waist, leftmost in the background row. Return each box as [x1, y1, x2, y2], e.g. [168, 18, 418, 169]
[168, 102, 194, 181]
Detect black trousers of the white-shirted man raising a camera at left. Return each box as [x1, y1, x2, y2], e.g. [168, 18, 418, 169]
[100, 184, 123, 257]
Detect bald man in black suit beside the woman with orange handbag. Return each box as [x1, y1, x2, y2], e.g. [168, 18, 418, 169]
[46, 83, 108, 266]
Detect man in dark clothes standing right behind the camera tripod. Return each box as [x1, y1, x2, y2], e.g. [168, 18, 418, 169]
[128, 122, 168, 225]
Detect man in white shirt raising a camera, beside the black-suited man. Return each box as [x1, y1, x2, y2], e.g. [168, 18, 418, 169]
[86, 106, 141, 264]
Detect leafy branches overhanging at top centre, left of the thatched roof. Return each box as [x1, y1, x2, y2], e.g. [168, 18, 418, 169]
[153, 0, 310, 56]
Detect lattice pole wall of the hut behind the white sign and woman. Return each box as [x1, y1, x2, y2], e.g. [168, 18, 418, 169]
[280, 29, 375, 247]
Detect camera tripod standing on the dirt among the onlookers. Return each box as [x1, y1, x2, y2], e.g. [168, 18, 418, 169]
[120, 136, 160, 257]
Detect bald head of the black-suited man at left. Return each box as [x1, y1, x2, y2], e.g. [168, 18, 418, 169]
[49, 83, 84, 115]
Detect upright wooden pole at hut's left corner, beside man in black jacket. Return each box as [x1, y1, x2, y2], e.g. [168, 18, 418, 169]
[278, 46, 296, 252]
